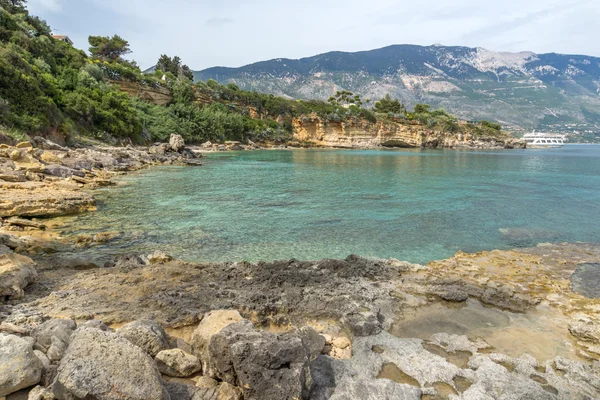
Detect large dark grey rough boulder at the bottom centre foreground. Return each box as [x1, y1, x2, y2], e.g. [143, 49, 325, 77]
[208, 320, 325, 400]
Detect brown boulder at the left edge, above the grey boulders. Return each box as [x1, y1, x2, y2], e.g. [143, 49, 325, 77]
[0, 249, 37, 301]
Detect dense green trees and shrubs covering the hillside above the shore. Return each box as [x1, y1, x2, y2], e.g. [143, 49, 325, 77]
[0, 0, 506, 143]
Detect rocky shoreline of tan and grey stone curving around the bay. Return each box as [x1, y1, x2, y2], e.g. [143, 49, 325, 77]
[0, 136, 600, 400]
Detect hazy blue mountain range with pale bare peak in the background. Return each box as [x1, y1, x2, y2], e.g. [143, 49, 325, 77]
[194, 45, 600, 132]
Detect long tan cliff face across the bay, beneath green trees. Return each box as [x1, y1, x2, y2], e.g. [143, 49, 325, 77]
[293, 115, 525, 149]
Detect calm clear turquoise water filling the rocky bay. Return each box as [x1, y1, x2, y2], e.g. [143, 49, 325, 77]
[65, 145, 600, 263]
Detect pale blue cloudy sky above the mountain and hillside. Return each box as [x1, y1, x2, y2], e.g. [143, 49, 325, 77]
[28, 0, 600, 70]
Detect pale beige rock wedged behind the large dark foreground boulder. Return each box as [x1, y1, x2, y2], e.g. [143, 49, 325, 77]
[191, 310, 244, 376]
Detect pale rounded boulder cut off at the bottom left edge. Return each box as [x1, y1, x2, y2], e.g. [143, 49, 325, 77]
[0, 334, 44, 396]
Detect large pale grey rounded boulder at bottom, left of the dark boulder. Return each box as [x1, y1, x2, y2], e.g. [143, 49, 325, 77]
[53, 328, 170, 400]
